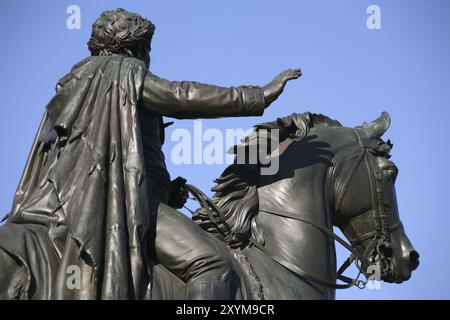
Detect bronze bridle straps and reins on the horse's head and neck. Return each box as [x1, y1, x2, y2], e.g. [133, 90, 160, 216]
[186, 128, 402, 289]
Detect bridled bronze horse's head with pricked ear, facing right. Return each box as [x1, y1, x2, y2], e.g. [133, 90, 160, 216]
[331, 112, 419, 283]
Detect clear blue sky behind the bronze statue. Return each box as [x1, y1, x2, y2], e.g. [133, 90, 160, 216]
[0, 0, 450, 299]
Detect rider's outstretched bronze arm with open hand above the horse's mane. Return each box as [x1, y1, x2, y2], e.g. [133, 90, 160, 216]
[142, 69, 301, 119]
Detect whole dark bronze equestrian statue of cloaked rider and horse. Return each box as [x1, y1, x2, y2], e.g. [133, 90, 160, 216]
[0, 9, 418, 299]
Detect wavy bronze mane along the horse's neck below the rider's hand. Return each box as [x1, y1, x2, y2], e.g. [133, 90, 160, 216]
[192, 112, 342, 248]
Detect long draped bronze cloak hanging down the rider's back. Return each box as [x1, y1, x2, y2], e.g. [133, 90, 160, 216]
[0, 56, 155, 299]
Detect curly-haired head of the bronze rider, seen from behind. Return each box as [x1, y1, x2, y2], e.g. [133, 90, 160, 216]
[88, 8, 155, 67]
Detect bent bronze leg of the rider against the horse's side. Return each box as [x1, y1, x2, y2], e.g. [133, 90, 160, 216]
[155, 204, 233, 300]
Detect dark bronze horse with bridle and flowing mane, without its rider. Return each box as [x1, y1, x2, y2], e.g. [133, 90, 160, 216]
[0, 113, 419, 300]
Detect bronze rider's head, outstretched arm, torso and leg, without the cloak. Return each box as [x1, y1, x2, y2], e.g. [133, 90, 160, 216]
[88, 9, 301, 299]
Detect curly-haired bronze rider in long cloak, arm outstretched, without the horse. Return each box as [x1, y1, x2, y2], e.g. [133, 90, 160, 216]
[0, 9, 301, 299]
